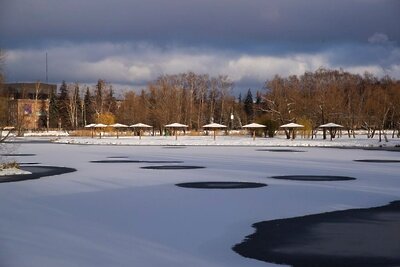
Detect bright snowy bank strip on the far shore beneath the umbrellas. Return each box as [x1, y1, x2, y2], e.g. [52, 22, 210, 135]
[55, 135, 400, 147]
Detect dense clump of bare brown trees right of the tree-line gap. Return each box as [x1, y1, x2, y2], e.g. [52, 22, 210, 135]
[263, 68, 400, 139]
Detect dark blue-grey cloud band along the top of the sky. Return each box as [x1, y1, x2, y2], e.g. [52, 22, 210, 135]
[0, 0, 400, 49]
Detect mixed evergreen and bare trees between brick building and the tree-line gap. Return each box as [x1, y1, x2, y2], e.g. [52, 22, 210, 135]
[49, 72, 260, 131]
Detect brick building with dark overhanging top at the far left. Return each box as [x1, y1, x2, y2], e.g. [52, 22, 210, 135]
[0, 82, 57, 130]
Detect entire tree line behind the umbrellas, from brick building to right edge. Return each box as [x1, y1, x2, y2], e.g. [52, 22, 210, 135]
[39, 68, 400, 139]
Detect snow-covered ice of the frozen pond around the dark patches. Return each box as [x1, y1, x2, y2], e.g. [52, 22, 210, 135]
[0, 141, 400, 267]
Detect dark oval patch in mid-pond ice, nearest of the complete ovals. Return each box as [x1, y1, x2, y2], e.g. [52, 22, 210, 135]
[176, 182, 267, 189]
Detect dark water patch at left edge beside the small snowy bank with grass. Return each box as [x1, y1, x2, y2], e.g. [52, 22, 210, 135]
[0, 166, 76, 183]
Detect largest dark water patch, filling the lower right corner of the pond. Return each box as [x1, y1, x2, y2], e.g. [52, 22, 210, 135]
[232, 201, 400, 267]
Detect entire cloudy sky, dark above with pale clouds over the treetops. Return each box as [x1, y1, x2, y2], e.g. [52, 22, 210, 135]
[0, 0, 400, 93]
